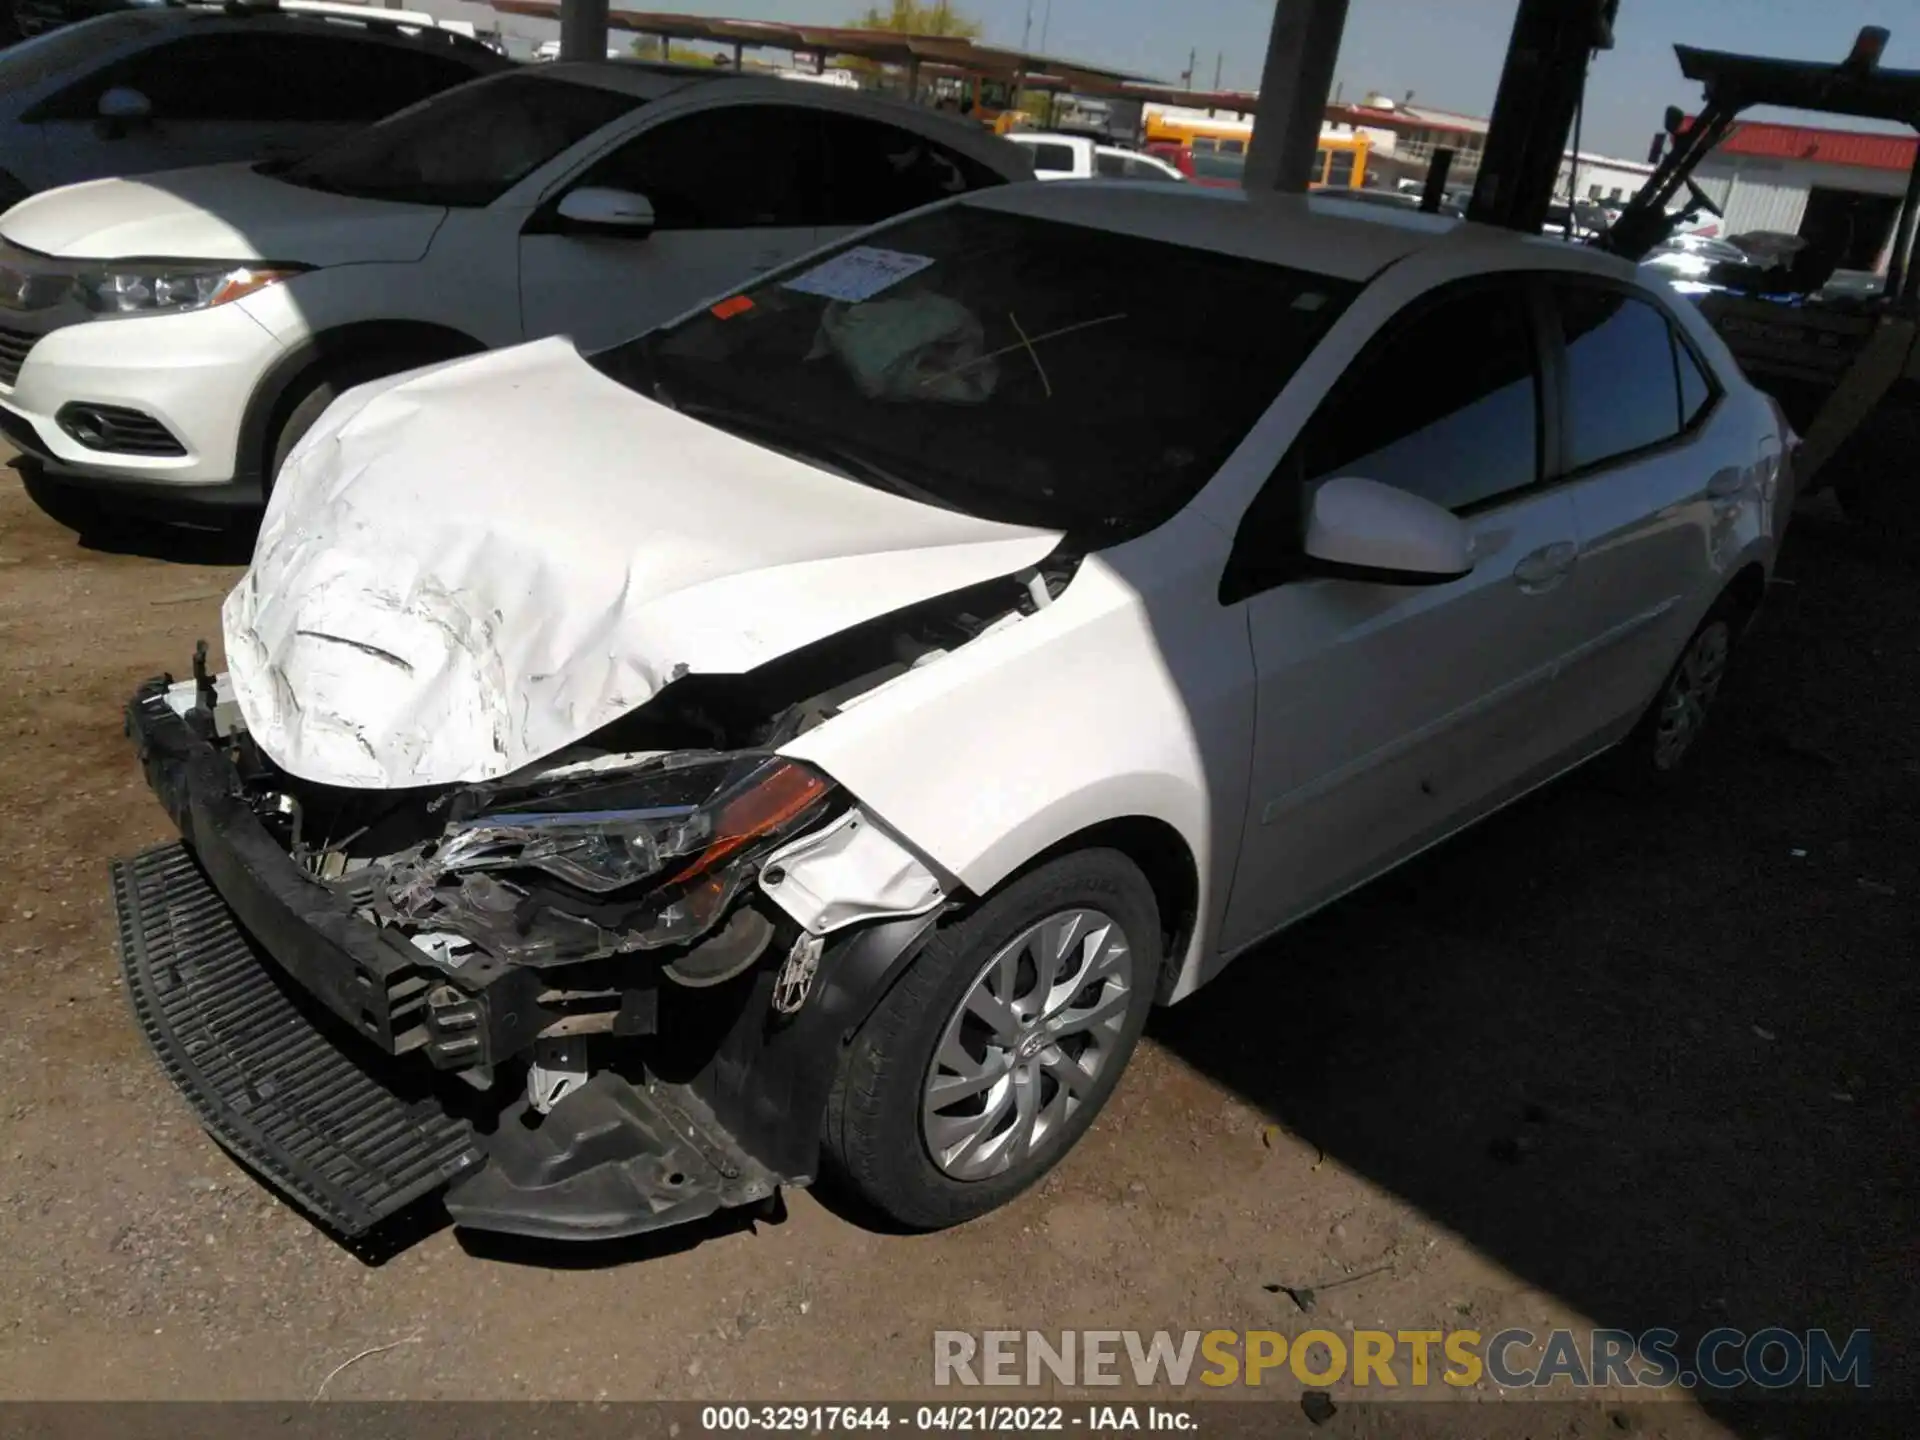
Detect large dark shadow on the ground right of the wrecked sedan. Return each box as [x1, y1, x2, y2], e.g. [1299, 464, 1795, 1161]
[1152, 518, 1920, 1434]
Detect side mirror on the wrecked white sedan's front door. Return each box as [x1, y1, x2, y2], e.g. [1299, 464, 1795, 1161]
[1306, 476, 1473, 586]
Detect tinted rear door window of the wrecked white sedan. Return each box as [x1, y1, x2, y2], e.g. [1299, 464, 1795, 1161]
[1553, 282, 1682, 470]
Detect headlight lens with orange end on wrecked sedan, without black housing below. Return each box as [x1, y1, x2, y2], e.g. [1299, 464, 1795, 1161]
[432, 756, 833, 895]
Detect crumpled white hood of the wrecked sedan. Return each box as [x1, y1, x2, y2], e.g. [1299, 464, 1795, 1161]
[223, 340, 1060, 789]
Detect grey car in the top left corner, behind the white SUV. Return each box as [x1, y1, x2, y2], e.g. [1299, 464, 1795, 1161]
[0, 0, 509, 209]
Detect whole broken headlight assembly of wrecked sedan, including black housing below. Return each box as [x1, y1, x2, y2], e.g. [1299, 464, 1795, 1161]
[371, 753, 835, 966]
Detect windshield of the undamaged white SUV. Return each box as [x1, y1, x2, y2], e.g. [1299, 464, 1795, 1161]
[280, 75, 641, 205]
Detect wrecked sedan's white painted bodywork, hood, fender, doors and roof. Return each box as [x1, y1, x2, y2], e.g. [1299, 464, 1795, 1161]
[206, 184, 1791, 998]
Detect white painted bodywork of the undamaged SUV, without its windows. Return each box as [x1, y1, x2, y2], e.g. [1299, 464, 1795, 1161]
[0, 61, 1031, 499]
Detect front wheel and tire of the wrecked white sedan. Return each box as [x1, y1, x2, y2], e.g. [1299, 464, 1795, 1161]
[824, 849, 1162, 1229]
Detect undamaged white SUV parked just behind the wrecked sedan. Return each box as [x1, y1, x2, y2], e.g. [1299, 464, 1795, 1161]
[0, 61, 1033, 528]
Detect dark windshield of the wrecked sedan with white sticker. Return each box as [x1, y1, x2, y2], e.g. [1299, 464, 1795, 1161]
[593, 205, 1357, 543]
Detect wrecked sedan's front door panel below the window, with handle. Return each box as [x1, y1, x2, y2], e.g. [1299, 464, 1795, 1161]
[1221, 493, 1578, 948]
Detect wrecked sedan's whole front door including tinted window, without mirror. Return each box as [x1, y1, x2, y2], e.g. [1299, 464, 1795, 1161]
[1223, 276, 1582, 948]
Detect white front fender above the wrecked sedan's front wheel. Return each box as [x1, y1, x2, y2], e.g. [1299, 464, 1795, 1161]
[783, 515, 1254, 993]
